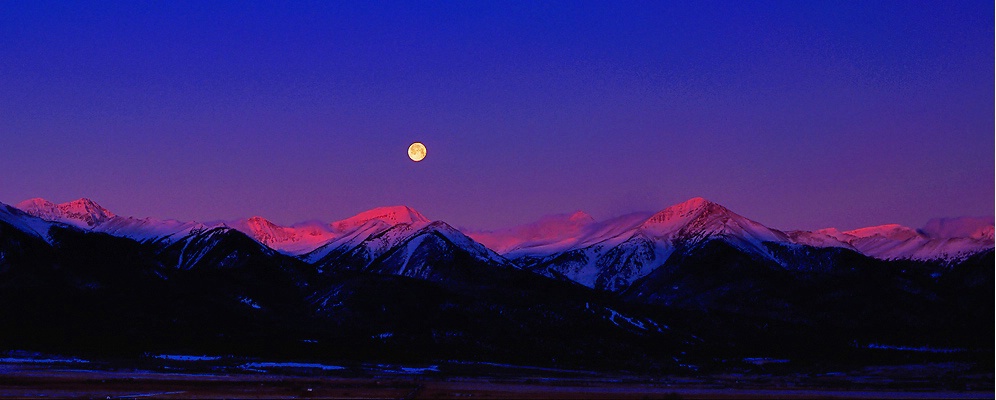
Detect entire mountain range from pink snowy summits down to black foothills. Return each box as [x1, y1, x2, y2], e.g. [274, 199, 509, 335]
[0, 198, 996, 369]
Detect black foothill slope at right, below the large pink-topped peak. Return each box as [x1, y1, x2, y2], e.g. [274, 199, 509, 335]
[621, 240, 994, 349]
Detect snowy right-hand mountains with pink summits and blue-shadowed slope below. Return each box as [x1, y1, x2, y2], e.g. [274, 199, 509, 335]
[482, 198, 993, 291]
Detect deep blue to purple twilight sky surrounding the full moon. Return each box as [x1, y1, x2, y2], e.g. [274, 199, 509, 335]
[0, 0, 994, 229]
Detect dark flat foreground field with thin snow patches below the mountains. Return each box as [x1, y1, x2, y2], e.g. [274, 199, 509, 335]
[0, 358, 993, 399]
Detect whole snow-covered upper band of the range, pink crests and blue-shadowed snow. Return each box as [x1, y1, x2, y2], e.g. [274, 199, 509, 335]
[9, 197, 994, 268]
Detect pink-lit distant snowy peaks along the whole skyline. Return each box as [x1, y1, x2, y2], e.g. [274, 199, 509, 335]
[16, 198, 993, 261]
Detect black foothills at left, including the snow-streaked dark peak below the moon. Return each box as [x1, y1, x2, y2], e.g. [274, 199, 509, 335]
[0, 202, 690, 368]
